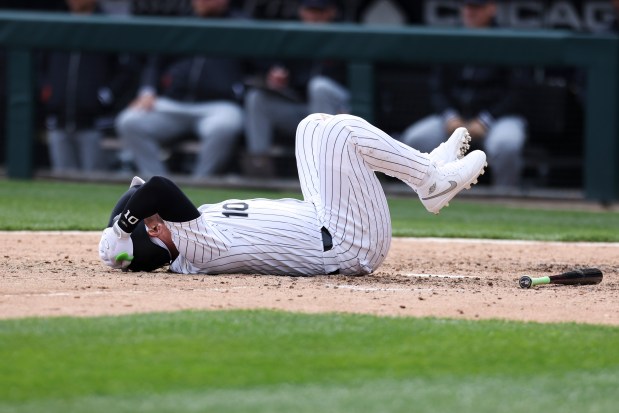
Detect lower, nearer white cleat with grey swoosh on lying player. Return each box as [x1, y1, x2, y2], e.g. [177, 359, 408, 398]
[417, 151, 488, 214]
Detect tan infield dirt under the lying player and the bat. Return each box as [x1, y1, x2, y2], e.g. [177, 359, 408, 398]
[0, 232, 619, 325]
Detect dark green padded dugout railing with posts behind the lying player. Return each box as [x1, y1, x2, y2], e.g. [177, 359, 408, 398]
[0, 12, 619, 203]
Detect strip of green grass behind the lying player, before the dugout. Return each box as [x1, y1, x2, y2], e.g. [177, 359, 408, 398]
[0, 181, 619, 242]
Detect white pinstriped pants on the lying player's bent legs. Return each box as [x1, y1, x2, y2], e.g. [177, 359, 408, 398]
[296, 114, 430, 274]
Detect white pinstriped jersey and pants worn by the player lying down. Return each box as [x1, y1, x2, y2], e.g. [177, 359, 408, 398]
[166, 114, 430, 275]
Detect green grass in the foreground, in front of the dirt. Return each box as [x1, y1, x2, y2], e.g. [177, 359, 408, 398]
[0, 311, 619, 413]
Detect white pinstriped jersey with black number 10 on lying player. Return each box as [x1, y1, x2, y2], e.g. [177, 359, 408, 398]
[166, 198, 325, 275]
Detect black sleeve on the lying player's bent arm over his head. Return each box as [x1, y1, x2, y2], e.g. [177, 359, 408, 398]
[118, 176, 200, 232]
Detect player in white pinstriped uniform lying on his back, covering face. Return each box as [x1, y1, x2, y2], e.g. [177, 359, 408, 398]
[99, 114, 486, 275]
